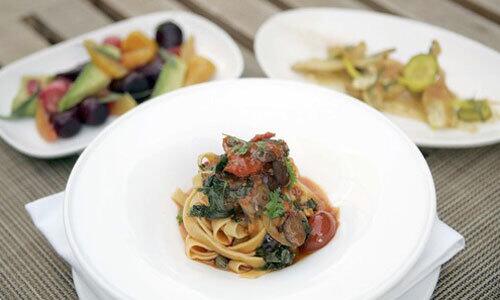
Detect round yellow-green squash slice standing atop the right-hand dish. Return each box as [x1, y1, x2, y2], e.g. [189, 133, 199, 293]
[400, 54, 439, 92]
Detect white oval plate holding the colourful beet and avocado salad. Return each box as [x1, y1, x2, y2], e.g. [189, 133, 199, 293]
[0, 11, 243, 158]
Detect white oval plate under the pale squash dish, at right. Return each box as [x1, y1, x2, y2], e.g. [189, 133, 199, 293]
[254, 8, 500, 147]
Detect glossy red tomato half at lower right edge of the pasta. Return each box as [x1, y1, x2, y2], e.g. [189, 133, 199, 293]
[302, 211, 338, 253]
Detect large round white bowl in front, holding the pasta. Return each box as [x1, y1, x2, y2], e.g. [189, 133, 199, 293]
[64, 79, 435, 299]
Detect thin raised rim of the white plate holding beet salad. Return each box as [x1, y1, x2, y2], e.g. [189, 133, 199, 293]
[0, 10, 245, 159]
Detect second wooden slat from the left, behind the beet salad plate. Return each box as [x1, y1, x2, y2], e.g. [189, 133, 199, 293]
[36, 0, 111, 39]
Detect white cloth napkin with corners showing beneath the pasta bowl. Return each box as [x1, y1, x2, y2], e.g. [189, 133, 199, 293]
[26, 192, 465, 300]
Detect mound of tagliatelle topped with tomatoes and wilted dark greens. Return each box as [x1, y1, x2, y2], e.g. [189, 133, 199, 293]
[172, 133, 338, 278]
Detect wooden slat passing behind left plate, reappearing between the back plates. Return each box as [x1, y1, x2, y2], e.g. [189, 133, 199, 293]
[99, 0, 264, 77]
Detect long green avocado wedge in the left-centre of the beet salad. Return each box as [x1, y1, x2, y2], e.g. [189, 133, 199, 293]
[57, 63, 111, 111]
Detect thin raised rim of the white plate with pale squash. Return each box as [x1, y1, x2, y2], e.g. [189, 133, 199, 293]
[253, 6, 500, 149]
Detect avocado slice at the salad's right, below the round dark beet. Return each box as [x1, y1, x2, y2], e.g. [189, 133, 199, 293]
[151, 54, 187, 97]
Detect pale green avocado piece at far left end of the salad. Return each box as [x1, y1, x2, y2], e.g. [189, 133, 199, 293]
[11, 75, 52, 117]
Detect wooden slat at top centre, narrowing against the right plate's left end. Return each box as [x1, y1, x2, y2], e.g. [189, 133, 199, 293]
[182, 0, 280, 49]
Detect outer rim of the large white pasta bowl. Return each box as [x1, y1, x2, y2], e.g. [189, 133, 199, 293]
[63, 78, 437, 299]
